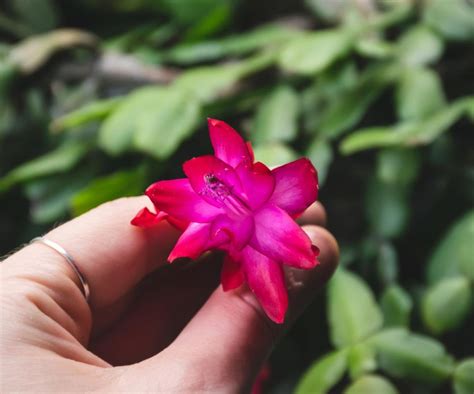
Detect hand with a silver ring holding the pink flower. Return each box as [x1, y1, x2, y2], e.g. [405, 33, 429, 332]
[0, 197, 338, 393]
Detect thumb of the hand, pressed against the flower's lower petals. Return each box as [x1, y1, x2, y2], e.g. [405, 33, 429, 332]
[121, 226, 338, 392]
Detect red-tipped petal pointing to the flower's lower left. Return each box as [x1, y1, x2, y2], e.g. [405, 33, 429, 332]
[168, 223, 228, 262]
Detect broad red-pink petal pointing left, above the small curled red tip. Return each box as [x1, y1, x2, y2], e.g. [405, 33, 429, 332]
[145, 179, 222, 223]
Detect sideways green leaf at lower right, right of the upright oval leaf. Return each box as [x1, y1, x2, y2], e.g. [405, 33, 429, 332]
[369, 328, 454, 384]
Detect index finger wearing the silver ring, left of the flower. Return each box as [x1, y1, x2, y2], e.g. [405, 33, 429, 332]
[3, 197, 178, 308]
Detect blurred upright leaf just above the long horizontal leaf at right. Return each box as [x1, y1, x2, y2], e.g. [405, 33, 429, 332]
[396, 67, 446, 120]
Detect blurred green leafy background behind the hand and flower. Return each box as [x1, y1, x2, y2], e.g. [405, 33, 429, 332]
[0, 0, 474, 394]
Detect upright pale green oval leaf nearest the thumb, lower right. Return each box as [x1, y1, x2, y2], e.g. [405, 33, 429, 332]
[328, 268, 382, 348]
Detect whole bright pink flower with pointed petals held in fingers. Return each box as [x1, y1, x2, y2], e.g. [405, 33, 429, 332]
[132, 119, 319, 323]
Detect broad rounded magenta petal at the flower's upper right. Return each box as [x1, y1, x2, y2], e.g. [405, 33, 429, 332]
[269, 158, 318, 216]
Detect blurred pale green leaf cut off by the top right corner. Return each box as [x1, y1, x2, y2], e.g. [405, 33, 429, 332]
[423, 0, 474, 40]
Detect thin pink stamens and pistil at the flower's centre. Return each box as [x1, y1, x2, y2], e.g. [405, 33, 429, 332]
[204, 173, 252, 218]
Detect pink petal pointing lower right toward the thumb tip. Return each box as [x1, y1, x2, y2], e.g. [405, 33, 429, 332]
[249, 205, 318, 269]
